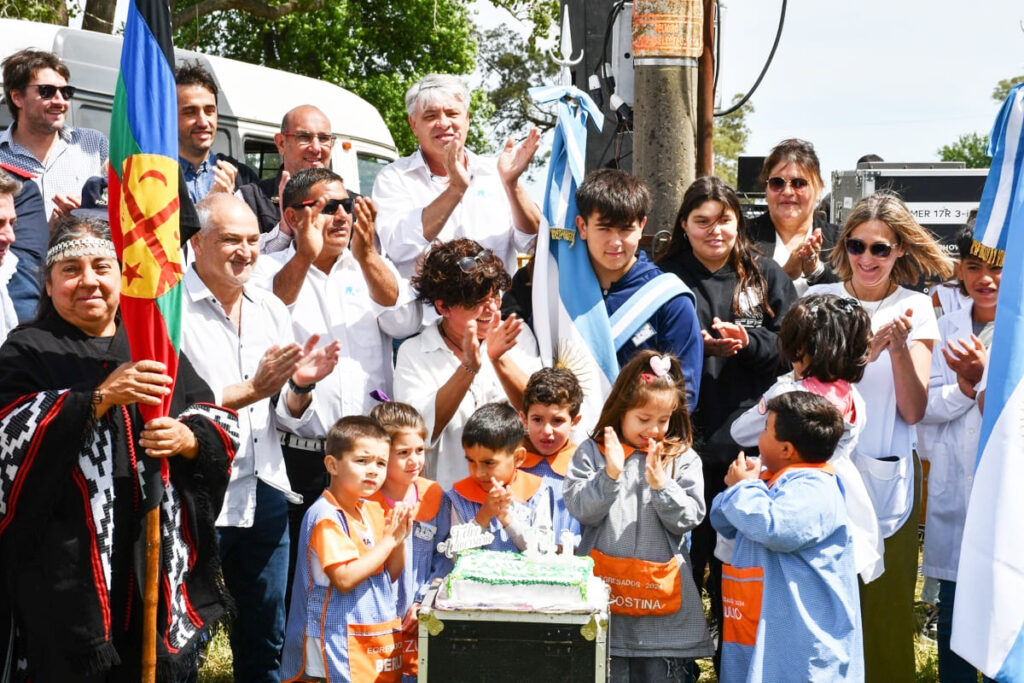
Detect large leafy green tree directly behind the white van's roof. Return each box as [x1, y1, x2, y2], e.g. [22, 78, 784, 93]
[174, 0, 487, 154]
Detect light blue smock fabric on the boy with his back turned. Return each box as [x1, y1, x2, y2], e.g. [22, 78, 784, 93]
[711, 468, 864, 683]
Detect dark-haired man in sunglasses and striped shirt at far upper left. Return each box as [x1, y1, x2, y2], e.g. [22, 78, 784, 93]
[0, 49, 108, 229]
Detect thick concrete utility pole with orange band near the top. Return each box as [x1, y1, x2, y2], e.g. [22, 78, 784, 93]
[633, 0, 703, 240]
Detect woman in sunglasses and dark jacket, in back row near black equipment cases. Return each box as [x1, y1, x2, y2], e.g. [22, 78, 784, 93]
[748, 138, 839, 295]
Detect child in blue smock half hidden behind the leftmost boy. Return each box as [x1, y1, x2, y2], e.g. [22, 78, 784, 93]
[370, 401, 444, 681]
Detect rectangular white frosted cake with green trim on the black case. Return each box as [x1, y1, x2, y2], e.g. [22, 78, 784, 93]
[438, 550, 608, 611]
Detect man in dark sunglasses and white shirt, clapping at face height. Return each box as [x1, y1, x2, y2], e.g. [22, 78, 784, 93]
[253, 168, 423, 598]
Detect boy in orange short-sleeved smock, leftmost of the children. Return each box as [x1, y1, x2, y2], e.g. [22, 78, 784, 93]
[282, 416, 413, 683]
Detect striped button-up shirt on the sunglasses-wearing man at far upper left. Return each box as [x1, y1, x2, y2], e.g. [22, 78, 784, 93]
[0, 124, 110, 218]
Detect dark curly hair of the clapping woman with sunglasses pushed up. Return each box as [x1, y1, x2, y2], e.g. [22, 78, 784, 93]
[412, 239, 512, 312]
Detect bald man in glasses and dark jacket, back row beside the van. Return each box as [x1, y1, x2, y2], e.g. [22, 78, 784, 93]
[238, 100, 335, 241]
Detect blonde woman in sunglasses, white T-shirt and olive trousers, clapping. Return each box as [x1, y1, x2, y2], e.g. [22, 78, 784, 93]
[807, 193, 953, 681]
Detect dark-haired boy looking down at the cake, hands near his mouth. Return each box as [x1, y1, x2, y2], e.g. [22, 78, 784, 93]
[435, 402, 573, 575]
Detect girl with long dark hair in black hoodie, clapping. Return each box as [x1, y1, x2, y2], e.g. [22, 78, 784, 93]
[658, 177, 797, 661]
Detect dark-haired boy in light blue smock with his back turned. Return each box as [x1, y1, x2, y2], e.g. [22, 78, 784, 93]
[711, 391, 864, 683]
